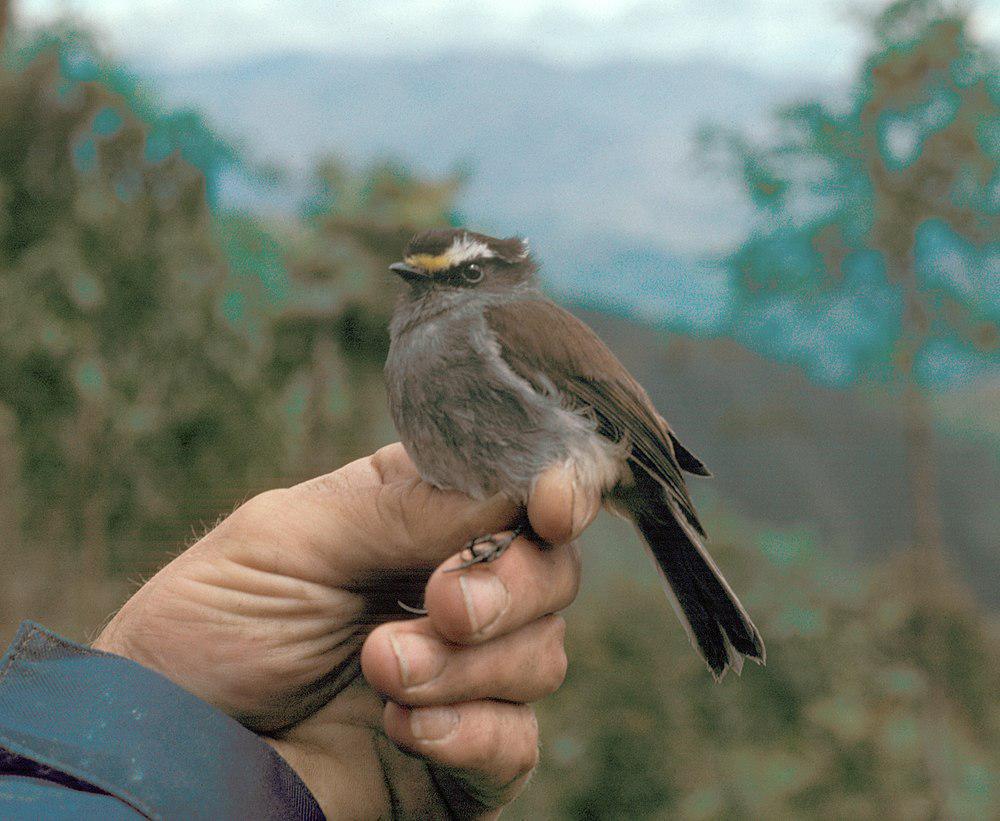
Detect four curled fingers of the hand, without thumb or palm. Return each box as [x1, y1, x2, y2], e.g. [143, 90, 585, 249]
[361, 462, 584, 817]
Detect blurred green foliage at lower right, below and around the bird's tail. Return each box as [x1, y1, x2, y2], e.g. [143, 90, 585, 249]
[515, 520, 1000, 819]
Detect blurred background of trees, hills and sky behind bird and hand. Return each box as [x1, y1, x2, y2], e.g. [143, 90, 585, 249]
[0, 0, 1000, 819]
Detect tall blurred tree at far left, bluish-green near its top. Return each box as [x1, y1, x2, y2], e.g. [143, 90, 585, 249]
[0, 43, 273, 596]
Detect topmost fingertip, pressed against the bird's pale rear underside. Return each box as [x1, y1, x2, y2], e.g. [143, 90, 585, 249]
[528, 462, 601, 544]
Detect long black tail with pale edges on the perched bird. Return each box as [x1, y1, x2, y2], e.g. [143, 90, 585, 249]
[628, 486, 765, 681]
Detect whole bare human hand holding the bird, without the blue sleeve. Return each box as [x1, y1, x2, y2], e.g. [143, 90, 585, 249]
[94, 445, 599, 817]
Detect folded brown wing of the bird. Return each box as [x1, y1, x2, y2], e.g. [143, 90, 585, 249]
[486, 297, 707, 535]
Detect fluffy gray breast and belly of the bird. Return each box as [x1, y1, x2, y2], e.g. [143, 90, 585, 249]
[386, 314, 594, 501]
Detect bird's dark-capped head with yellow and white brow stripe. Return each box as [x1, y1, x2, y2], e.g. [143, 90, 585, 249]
[389, 228, 536, 290]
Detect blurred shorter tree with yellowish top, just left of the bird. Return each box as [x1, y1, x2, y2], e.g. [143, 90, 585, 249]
[271, 159, 461, 473]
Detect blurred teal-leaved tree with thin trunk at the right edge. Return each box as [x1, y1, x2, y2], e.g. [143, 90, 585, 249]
[715, 0, 1000, 584]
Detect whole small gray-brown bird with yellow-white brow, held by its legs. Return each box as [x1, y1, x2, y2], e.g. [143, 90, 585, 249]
[385, 228, 765, 681]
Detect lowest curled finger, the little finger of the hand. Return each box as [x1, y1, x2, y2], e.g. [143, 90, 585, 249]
[383, 701, 538, 807]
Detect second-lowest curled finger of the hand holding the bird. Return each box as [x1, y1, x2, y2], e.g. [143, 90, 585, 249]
[361, 616, 566, 706]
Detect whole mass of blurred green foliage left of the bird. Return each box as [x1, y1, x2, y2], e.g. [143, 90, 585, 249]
[0, 28, 459, 560]
